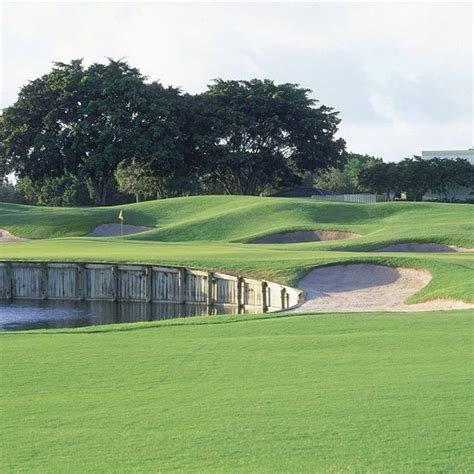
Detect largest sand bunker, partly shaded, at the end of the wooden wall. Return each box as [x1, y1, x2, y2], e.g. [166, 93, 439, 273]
[290, 264, 474, 313]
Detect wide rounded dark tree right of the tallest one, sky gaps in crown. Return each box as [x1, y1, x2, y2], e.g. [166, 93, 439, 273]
[194, 79, 345, 194]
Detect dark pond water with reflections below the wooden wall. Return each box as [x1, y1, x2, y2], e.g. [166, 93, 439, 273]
[0, 300, 243, 331]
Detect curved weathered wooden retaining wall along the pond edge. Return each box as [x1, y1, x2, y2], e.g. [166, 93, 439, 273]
[0, 262, 302, 313]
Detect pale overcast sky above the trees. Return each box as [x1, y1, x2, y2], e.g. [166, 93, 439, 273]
[1, 2, 474, 161]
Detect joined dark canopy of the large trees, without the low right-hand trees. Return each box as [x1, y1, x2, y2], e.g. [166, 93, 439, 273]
[0, 63, 345, 204]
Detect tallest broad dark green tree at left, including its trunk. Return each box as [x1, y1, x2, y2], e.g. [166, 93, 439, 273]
[0, 60, 169, 204]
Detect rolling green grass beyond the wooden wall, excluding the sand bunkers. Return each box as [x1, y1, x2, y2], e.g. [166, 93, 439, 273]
[0, 196, 474, 302]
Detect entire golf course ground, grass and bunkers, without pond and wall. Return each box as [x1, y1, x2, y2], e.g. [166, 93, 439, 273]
[0, 196, 474, 473]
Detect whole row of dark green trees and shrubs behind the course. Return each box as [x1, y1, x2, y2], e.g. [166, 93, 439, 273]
[0, 59, 474, 206]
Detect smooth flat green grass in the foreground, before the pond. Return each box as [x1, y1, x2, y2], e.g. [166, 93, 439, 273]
[0, 311, 474, 472]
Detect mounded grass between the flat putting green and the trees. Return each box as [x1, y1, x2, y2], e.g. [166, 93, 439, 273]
[0, 196, 474, 248]
